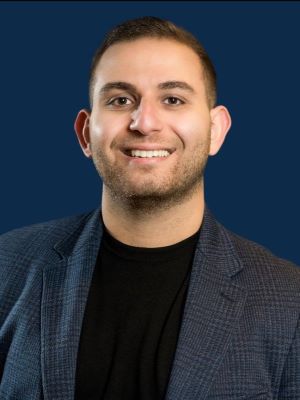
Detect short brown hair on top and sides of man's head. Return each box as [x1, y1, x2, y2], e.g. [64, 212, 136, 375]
[89, 17, 217, 108]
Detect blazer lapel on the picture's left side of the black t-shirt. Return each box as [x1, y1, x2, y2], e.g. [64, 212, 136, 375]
[41, 209, 102, 400]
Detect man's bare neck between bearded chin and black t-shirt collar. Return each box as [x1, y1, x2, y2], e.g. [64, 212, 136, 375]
[102, 185, 204, 248]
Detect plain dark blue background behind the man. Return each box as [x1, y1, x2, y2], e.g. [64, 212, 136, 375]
[0, 1, 300, 264]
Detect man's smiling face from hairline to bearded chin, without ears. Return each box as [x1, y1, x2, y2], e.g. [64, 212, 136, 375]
[89, 38, 211, 209]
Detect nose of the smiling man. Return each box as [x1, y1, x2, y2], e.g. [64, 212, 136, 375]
[129, 99, 162, 135]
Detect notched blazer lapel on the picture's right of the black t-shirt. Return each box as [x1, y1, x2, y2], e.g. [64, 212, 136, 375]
[166, 210, 246, 400]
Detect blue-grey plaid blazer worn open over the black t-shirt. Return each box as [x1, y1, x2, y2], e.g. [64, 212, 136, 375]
[0, 209, 300, 400]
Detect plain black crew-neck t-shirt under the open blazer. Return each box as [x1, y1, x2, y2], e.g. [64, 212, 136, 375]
[75, 225, 199, 400]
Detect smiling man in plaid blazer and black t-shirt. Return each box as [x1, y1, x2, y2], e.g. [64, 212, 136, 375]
[0, 17, 300, 400]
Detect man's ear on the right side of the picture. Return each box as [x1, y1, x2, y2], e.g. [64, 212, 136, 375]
[209, 106, 231, 156]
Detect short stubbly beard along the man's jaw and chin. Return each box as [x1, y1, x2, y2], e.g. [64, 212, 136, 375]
[92, 138, 210, 214]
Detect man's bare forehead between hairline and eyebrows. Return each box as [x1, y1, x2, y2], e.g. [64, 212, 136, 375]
[95, 38, 203, 91]
